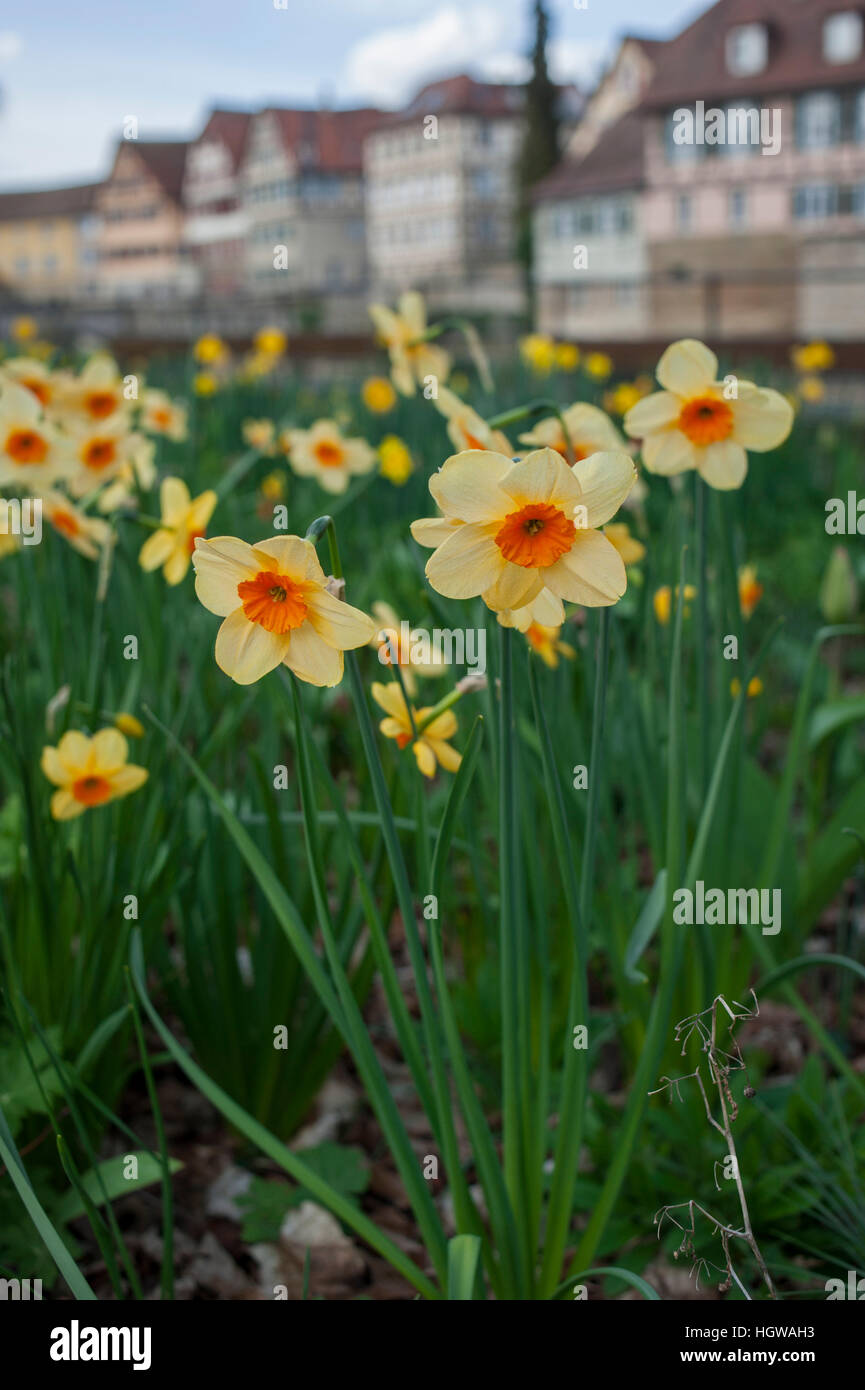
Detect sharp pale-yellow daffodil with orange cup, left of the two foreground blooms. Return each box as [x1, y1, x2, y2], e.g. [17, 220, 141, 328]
[192, 535, 375, 685]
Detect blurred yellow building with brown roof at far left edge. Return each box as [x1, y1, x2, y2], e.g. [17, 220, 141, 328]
[0, 183, 99, 300]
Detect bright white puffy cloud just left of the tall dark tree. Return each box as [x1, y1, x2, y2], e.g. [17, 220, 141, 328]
[343, 4, 510, 104]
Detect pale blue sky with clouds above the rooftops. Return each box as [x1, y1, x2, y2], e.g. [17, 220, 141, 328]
[0, 0, 705, 190]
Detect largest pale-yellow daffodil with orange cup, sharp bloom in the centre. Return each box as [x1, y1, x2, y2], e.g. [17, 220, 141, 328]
[412, 449, 637, 612]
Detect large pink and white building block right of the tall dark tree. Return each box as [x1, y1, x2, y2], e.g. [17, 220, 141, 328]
[535, 0, 865, 339]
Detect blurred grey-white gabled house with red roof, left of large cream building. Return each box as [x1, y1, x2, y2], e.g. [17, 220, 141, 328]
[241, 108, 381, 305]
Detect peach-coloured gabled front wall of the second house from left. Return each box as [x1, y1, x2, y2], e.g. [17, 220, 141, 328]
[97, 140, 196, 299]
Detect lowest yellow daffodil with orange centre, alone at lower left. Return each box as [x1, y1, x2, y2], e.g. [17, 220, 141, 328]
[42, 728, 147, 820]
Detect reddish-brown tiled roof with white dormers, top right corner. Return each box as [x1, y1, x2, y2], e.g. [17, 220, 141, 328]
[642, 0, 865, 108]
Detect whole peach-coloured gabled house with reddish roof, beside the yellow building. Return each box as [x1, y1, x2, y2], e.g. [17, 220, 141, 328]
[96, 139, 196, 300]
